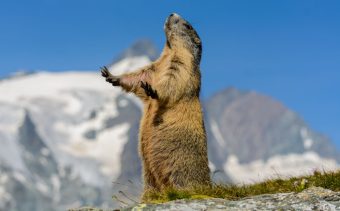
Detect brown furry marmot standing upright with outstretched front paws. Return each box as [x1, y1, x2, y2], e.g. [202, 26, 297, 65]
[101, 14, 210, 193]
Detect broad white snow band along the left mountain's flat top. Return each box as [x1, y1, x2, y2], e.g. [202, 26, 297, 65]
[0, 71, 113, 103]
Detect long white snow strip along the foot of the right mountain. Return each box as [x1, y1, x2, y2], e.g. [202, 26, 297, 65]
[224, 152, 340, 184]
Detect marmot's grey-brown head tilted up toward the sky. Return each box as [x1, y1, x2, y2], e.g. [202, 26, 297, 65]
[164, 13, 202, 64]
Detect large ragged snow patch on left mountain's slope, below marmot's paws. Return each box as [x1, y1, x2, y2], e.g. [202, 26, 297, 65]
[53, 95, 129, 185]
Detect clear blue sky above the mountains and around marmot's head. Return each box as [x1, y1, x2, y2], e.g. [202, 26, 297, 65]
[0, 0, 340, 149]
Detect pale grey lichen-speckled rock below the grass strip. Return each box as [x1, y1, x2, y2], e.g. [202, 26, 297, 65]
[123, 187, 340, 211]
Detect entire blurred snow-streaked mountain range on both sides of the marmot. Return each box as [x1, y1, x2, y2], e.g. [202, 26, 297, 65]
[0, 41, 340, 210]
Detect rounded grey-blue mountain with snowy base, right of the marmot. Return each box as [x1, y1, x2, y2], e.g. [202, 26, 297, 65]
[205, 88, 340, 183]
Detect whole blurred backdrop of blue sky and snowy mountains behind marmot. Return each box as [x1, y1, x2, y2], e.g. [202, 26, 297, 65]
[0, 0, 340, 210]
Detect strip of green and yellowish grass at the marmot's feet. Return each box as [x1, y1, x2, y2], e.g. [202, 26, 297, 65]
[144, 171, 340, 203]
